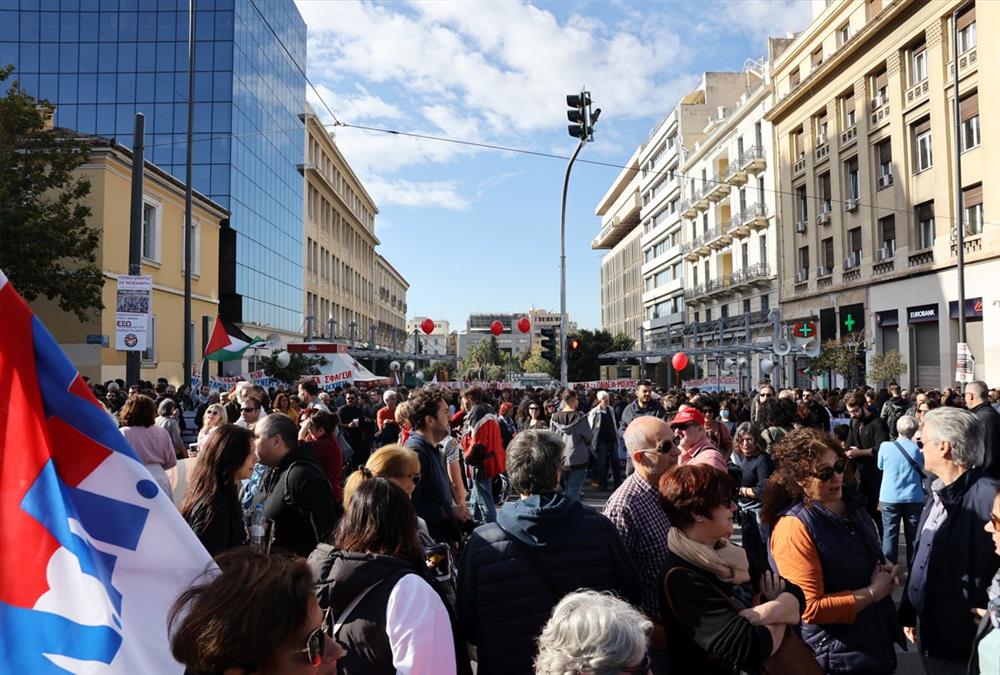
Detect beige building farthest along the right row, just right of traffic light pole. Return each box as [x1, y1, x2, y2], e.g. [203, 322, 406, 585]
[590, 146, 643, 342]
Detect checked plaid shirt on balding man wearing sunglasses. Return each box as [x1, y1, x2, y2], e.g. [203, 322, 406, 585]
[604, 473, 670, 623]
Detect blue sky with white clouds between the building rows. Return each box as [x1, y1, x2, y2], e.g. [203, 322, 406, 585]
[296, 0, 811, 336]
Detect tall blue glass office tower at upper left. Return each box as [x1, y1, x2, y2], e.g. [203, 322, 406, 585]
[0, 0, 306, 334]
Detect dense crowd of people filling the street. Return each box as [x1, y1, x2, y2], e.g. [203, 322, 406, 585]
[84, 374, 1000, 675]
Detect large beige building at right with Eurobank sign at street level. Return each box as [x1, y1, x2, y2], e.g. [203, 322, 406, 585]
[767, 0, 1000, 387]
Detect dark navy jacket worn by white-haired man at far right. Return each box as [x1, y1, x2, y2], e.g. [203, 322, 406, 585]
[899, 467, 1000, 661]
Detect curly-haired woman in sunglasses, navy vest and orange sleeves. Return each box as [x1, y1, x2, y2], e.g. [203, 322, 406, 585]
[761, 429, 903, 675]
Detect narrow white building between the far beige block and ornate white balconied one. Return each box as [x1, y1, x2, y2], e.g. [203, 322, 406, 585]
[639, 73, 747, 362]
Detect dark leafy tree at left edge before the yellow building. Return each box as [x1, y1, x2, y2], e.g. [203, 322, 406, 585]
[0, 66, 104, 321]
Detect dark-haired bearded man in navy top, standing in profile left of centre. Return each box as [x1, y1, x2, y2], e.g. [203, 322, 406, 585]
[404, 387, 465, 543]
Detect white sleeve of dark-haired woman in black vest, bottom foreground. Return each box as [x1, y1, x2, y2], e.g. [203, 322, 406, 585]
[385, 574, 456, 675]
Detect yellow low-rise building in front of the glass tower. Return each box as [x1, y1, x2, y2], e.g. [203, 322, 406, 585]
[32, 138, 228, 384]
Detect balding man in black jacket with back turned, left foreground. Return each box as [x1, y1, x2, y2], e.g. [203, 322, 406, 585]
[253, 413, 337, 556]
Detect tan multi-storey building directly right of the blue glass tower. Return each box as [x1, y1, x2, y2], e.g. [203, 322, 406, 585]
[299, 105, 380, 342]
